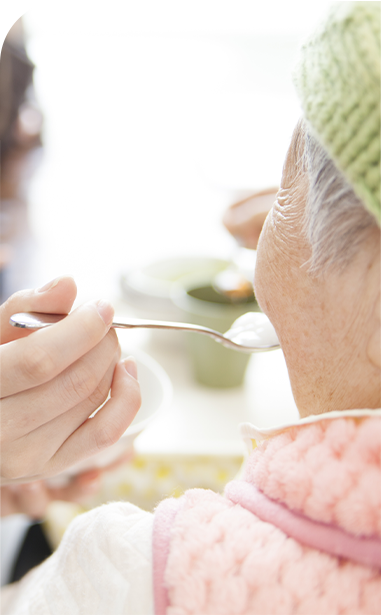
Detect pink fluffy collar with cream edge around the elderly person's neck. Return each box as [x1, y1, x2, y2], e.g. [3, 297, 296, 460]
[243, 411, 381, 537]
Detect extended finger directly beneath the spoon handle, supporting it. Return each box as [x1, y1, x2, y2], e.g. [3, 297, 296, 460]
[0, 301, 114, 398]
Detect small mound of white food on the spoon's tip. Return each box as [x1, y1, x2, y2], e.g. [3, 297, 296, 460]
[224, 312, 279, 348]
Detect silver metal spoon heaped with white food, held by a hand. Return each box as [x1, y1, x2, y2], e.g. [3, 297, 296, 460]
[9, 312, 280, 353]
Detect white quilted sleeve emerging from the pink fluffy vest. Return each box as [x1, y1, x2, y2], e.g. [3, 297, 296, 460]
[0, 503, 154, 614]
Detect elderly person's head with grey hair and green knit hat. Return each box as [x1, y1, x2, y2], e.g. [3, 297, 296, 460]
[255, 2, 381, 416]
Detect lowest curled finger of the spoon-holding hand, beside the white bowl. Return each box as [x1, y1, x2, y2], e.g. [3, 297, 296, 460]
[48, 358, 141, 475]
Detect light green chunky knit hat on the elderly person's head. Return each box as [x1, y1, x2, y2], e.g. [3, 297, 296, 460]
[295, 2, 381, 227]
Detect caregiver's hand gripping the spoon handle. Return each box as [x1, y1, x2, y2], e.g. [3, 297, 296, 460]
[0, 278, 140, 485]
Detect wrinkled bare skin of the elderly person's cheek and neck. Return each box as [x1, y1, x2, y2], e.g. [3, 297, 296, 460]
[255, 131, 381, 417]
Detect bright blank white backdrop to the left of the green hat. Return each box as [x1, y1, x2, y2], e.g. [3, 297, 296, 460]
[3, 0, 328, 301]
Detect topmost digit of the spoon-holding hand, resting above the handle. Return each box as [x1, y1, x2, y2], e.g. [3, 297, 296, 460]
[0, 276, 77, 344]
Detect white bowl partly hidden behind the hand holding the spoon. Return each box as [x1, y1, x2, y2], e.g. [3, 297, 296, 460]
[48, 350, 173, 486]
